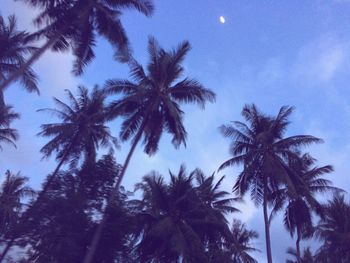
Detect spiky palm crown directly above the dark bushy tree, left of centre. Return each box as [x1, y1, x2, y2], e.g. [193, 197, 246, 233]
[39, 86, 116, 168]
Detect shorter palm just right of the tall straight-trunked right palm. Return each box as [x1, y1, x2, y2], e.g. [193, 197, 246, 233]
[269, 154, 340, 262]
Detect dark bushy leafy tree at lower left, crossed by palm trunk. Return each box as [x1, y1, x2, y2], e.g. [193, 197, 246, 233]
[26, 155, 133, 263]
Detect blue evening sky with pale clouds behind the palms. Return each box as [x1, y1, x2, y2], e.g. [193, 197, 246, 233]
[0, 0, 350, 262]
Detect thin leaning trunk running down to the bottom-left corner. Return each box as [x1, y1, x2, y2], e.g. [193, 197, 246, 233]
[0, 138, 78, 263]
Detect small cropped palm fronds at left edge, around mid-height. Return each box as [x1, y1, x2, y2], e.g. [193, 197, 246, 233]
[0, 105, 19, 149]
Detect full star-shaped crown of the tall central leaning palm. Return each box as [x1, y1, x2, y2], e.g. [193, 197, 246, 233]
[105, 38, 215, 157]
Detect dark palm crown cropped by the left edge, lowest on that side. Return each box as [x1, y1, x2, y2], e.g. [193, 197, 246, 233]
[0, 170, 34, 240]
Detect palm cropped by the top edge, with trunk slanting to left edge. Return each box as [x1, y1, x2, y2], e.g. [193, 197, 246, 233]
[0, 0, 153, 90]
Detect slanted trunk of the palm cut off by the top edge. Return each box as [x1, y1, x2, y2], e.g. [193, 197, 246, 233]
[0, 29, 64, 92]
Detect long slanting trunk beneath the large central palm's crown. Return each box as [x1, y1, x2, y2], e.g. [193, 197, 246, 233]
[83, 120, 147, 263]
